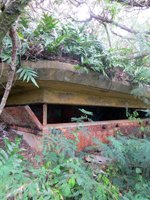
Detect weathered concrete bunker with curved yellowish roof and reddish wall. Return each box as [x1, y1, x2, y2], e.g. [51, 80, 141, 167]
[0, 61, 150, 150]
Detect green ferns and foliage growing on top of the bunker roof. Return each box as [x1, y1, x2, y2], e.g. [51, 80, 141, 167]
[1, 14, 150, 88]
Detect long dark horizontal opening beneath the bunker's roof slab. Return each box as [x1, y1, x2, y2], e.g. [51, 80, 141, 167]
[30, 104, 146, 124]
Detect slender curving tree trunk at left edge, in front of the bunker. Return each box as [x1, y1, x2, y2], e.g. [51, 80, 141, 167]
[0, 0, 31, 115]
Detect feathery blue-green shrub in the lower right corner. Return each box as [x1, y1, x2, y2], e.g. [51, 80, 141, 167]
[103, 136, 150, 200]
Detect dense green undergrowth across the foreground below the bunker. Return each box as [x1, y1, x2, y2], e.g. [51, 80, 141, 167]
[0, 122, 150, 200]
